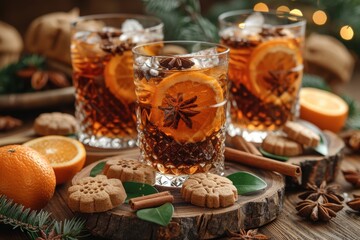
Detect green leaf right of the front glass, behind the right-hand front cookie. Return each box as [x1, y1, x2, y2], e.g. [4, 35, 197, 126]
[227, 172, 267, 195]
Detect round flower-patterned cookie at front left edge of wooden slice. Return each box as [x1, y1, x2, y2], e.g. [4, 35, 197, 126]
[68, 175, 126, 213]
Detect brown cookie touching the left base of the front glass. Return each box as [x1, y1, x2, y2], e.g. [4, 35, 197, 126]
[104, 156, 156, 185]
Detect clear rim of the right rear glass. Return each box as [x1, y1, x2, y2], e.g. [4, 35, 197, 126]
[218, 9, 306, 28]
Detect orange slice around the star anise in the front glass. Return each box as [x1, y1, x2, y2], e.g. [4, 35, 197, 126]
[150, 72, 225, 143]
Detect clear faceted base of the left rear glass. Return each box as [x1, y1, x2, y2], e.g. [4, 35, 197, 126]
[78, 133, 137, 149]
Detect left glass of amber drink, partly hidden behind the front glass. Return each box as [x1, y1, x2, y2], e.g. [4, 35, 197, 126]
[71, 14, 163, 149]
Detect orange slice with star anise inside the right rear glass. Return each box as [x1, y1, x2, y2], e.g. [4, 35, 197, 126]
[249, 39, 302, 100]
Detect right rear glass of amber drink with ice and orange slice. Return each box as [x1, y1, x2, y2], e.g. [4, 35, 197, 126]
[219, 10, 306, 142]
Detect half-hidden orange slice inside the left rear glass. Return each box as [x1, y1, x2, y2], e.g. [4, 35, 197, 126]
[104, 51, 136, 103]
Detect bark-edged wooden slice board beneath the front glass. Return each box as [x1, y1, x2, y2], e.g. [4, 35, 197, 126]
[73, 154, 285, 239]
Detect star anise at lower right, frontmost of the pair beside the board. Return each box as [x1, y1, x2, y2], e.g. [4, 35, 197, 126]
[296, 196, 343, 222]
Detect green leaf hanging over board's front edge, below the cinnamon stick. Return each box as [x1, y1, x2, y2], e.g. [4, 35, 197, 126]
[136, 203, 174, 226]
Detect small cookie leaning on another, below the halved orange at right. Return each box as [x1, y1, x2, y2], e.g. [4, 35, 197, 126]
[283, 121, 320, 147]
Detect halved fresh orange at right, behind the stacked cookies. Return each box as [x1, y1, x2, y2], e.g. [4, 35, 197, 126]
[300, 88, 349, 133]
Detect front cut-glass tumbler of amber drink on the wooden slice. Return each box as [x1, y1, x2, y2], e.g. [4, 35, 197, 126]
[133, 41, 229, 186]
